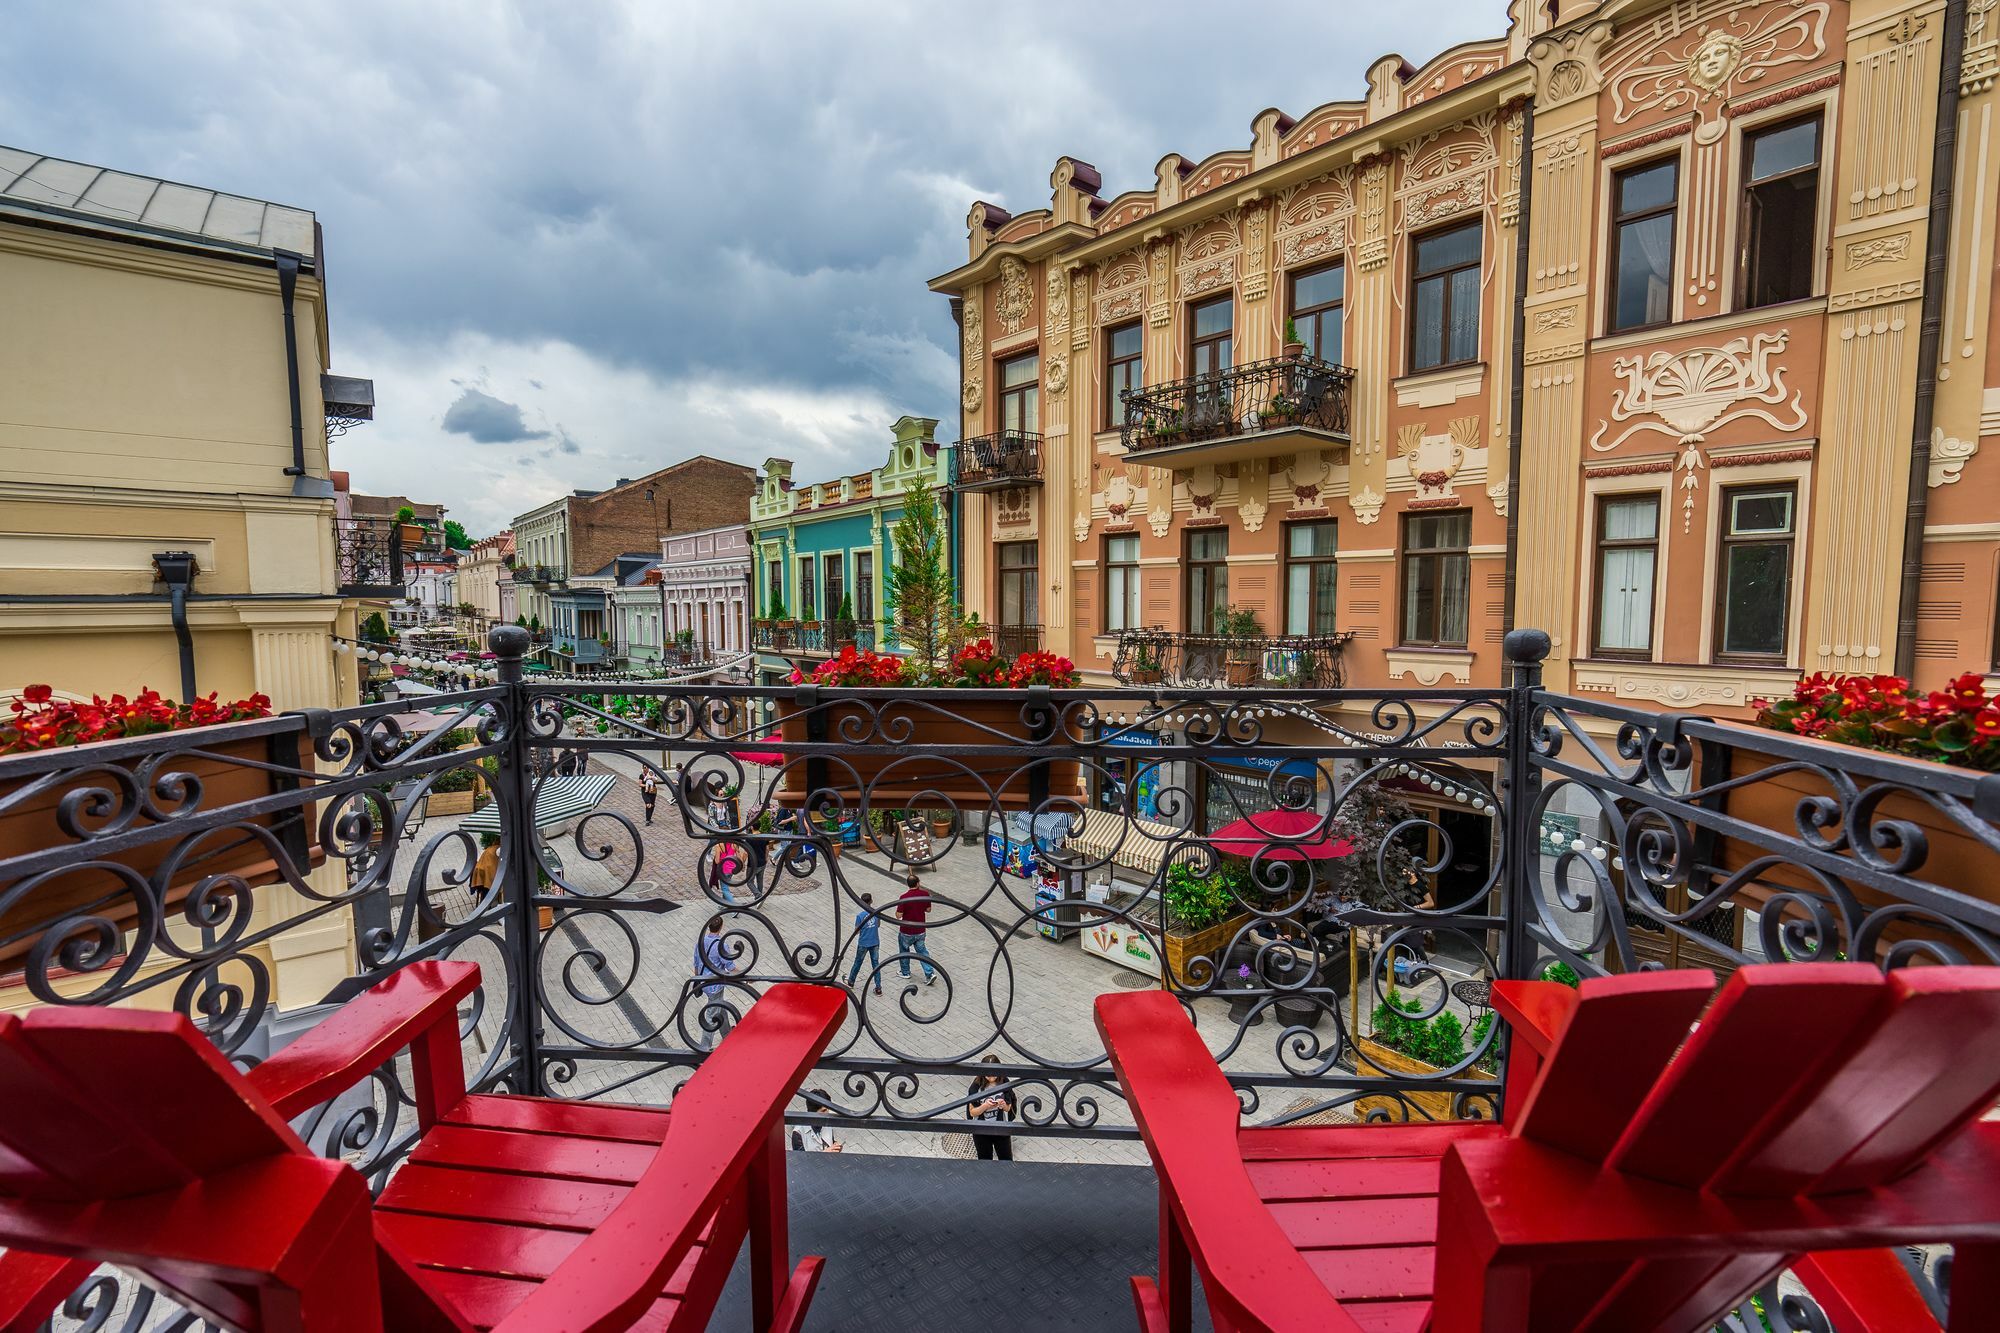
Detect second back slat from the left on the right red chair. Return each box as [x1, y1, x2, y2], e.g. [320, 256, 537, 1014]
[1606, 963, 1888, 1189]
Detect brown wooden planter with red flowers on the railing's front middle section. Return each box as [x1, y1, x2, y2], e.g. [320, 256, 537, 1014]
[776, 638, 1082, 809]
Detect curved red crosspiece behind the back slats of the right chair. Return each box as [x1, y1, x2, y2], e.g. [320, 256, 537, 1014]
[1438, 1123, 2000, 1273]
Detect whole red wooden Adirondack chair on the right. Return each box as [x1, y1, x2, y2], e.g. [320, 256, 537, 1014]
[1096, 963, 2000, 1333]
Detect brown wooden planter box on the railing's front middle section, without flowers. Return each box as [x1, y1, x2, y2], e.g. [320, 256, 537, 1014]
[774, 691, 1082, 811]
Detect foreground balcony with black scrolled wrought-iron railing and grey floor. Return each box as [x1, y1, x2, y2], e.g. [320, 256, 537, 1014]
[0, 626, 2000, 1333]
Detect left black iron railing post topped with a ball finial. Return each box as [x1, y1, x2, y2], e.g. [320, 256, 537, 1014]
[486, 624, 546, 1095]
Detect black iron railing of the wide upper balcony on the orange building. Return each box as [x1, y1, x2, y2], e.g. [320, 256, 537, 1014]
[1120, 356, 1354, 452]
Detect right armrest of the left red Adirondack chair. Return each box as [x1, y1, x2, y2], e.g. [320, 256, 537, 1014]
[494, 983, 846, 1333]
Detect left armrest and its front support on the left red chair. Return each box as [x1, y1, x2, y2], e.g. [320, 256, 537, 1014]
[248, 959, 480, 1129]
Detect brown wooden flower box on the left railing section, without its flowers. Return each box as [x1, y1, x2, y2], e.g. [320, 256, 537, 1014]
[0, 723, 326, 973]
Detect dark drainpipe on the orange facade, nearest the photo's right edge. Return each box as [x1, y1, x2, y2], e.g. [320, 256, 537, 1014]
[1896, 0, 1978, 677]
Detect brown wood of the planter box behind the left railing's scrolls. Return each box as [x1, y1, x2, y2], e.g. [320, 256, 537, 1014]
[0, 723, 326, 973]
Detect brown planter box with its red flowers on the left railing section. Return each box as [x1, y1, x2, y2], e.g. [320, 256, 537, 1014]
[0, 685, 324, 971]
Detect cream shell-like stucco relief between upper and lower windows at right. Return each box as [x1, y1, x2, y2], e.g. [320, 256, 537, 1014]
[1590, 330, 1808, 532]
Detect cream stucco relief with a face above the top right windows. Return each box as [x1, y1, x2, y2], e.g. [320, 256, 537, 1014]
[1612, 0, 1828, 144]
